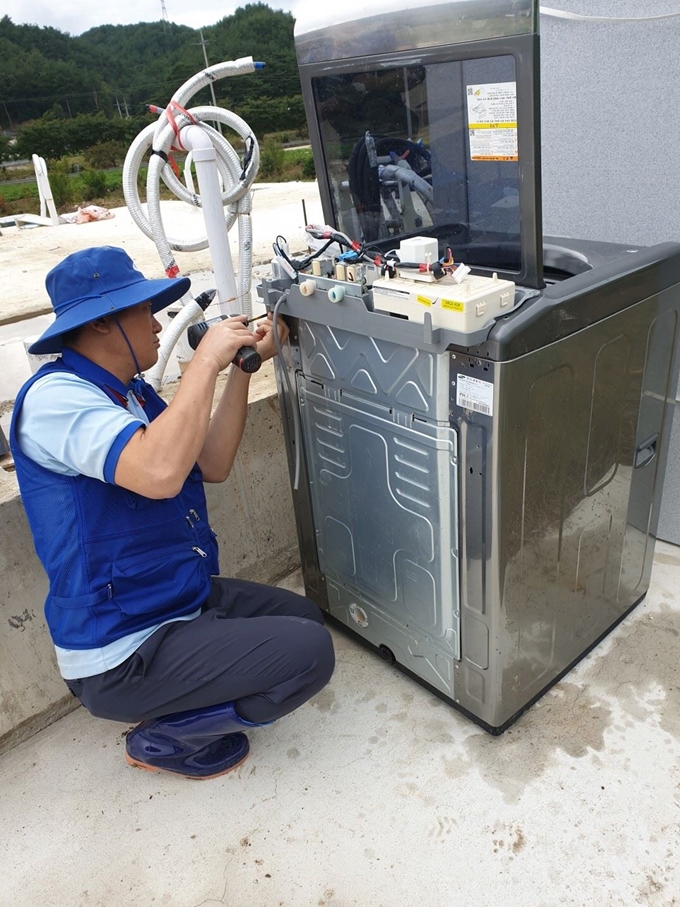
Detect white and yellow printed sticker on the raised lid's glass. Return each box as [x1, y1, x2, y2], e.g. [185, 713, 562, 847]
[467, 82, 519, 161]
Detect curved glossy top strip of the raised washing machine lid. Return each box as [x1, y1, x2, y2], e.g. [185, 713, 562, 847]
[295, 0, 538, 65]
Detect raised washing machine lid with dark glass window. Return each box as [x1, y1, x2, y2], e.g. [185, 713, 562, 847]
[296, 0, 543, 288]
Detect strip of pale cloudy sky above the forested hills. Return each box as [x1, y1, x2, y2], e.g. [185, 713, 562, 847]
[0, 0, 301, 35]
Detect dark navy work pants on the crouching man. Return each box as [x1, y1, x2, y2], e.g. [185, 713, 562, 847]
[67, 577, 335, 724]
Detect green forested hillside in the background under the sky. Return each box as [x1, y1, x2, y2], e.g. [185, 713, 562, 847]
[0, 3, 305, 159]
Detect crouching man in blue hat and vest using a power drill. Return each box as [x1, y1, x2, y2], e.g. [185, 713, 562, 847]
[10, 247, 334, 778]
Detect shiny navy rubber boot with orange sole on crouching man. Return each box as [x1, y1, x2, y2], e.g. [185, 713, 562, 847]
[125, 702, 264, 780]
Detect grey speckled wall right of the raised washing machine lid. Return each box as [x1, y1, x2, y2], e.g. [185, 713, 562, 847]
[540, 0, 680, 245]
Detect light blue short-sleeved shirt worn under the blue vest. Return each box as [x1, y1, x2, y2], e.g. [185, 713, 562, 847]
[17, 372, 200, 680]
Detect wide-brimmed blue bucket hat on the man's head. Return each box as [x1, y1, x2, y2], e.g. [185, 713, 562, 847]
[28, 246, 191, 353]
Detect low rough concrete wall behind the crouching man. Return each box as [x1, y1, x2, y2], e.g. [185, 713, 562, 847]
[0, 364, 299, 753]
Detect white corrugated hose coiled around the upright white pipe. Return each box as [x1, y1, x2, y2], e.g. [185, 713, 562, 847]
[123, 57, 264, 389]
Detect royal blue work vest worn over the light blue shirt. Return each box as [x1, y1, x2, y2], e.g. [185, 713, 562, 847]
[10, 349, 219, 649]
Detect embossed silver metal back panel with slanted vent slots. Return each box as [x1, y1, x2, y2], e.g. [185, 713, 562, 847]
[299, 377, 459, 680]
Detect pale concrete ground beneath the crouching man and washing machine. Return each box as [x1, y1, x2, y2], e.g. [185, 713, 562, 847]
[0, 542, 680, 907]
